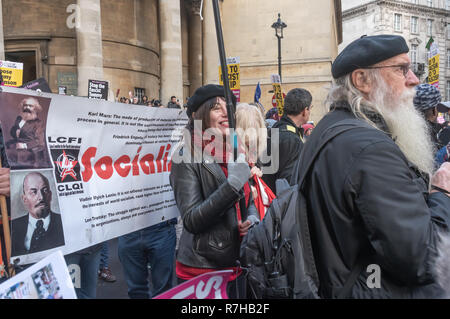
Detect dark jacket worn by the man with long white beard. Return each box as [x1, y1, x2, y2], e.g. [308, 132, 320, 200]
[291, 103, 450, 298]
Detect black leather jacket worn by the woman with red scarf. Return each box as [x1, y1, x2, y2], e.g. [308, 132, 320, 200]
[170, 146, 259, 269]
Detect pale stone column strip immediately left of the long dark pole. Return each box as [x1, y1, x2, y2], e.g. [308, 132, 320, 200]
[203, 0, 220, 84]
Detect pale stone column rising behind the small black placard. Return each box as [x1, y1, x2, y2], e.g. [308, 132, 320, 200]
[76, 0, 103, 96]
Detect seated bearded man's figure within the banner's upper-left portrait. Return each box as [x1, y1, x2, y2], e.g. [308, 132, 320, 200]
[7, 97, 48, 168]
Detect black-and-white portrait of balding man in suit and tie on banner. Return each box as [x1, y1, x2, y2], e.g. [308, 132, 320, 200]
[11, 169, 65, 263]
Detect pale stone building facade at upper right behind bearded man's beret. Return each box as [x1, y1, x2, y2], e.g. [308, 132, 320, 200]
[339, 0, 450, 100]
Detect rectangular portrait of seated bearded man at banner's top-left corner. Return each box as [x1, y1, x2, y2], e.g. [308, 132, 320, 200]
[0, 94, 52, 169]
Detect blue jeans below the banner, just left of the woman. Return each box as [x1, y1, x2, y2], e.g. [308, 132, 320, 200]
[118, 219, 176, 299]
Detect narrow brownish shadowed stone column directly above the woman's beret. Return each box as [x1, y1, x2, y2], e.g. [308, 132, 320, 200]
[189, 0, 203, 96]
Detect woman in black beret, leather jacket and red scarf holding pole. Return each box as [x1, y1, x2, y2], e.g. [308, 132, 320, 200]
[170, 84, 259, 298]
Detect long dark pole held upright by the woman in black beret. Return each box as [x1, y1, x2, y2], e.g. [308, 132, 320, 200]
[212, 0, 247, 221]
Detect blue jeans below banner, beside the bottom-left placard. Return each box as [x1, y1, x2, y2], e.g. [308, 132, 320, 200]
[64, 249, 100, 299]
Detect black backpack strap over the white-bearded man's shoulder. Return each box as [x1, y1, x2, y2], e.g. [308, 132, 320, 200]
[294, 118, 373, 298]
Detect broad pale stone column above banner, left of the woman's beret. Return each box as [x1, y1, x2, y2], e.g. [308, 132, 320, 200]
[159, 0, 184, 105]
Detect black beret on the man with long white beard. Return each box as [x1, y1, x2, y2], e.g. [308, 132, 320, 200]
[331, 34, 409, 79]
